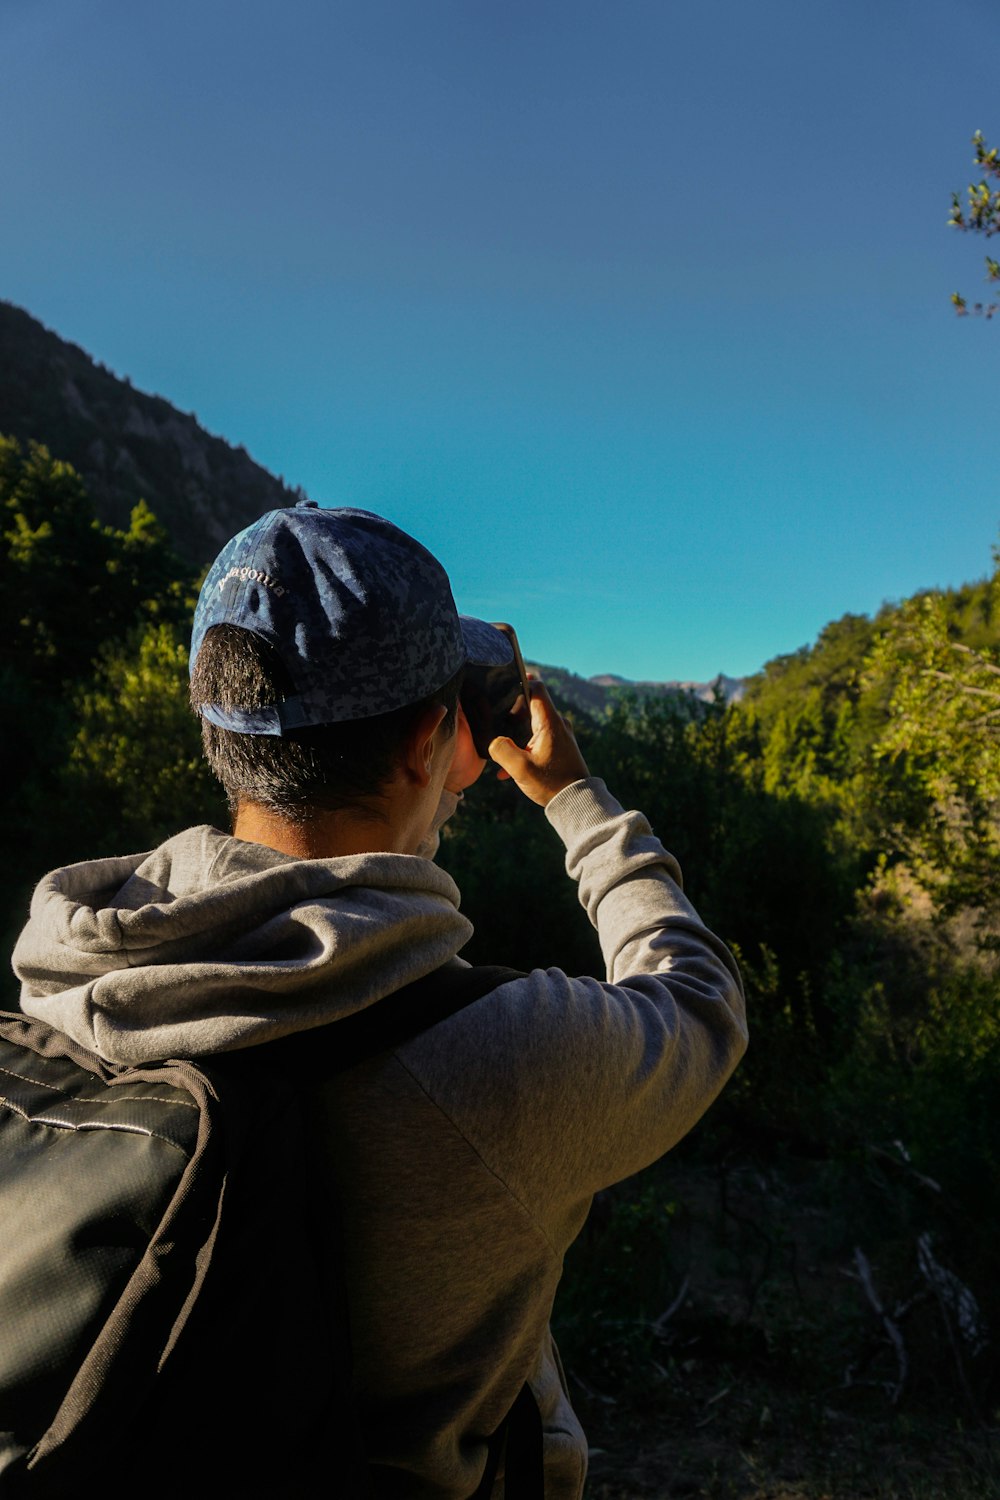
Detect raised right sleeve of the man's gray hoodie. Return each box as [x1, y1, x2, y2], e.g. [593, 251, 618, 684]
[395, 779, 747, 1223]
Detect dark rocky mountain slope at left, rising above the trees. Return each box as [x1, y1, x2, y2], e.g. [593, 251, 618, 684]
[0, 302, 300, 567]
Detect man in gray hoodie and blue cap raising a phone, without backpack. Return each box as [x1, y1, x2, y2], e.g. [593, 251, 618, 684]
[15, 503, 745, 1500]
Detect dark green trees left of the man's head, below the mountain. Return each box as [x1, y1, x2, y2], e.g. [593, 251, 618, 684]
[0, 438, 220, 947]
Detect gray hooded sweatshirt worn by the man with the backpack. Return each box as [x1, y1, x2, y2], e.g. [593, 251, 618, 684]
[13, 779, 747, 1500]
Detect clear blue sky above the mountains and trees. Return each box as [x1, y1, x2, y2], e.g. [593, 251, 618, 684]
[0, 0, 1000, 680]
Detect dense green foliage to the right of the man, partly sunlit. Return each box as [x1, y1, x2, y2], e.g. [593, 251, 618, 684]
[444, 543, 1000, 1440]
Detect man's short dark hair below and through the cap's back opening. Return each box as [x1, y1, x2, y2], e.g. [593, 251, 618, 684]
[190, 626, 462, 822]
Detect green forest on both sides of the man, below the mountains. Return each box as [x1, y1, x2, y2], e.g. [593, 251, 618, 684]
[0, 440, 1000, 1497]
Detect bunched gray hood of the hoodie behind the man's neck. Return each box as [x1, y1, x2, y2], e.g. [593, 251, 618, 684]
[13, 827, 472, 1065]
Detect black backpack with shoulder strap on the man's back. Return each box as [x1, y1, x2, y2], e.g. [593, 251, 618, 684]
[0, 966, 543, 1500]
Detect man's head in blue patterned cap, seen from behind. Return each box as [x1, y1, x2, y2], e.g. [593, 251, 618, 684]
[190, 503, 510, 821]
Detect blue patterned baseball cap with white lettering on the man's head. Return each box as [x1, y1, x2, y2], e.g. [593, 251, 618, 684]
[190, 500, 513, 735]
